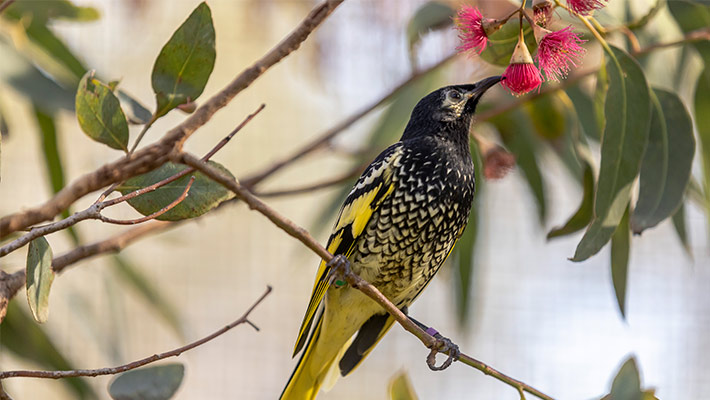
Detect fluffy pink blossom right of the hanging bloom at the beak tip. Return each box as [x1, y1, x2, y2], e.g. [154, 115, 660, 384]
[535, 26, 586, 81]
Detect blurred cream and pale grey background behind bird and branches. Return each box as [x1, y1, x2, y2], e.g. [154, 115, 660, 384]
[0, 0, 710, 400]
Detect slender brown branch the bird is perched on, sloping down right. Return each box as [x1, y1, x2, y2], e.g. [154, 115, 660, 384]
[178, 153, 553, 400]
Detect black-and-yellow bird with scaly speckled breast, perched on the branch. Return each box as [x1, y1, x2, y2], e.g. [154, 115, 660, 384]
[281, 76, 504, 400]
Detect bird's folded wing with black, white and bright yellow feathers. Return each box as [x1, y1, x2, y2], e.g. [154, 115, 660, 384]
[293, 145, 401, 356]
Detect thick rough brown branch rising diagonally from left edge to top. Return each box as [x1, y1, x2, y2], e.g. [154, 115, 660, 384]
[0, 0, 343, 239]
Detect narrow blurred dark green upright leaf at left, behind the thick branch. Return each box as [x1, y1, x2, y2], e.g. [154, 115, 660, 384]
[33, 104, 79, 244]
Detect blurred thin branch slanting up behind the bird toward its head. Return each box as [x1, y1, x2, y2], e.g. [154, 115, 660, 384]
[241, 54, 456, 188]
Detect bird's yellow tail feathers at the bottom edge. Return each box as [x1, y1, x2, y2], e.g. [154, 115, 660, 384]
[281, 315, 351, 400]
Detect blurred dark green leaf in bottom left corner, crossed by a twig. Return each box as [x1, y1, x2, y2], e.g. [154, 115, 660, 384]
[0, 301, 98, 399]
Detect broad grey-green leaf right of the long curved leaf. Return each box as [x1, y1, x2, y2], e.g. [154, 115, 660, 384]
[631, 89, 695, 234]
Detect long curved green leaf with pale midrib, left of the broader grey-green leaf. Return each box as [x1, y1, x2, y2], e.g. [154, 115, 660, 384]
[572, 47, 651, 261]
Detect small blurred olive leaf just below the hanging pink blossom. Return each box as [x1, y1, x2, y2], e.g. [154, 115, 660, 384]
[523, 92, 567, 140]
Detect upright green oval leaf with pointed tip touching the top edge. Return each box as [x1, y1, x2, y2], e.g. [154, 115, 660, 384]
[152, 3, 216, 117]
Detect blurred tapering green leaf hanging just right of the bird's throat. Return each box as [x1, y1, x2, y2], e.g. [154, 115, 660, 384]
[490, 110, 547, 226]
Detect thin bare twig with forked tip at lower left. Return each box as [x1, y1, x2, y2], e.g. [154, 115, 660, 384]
[0, 286, 271, 380]
